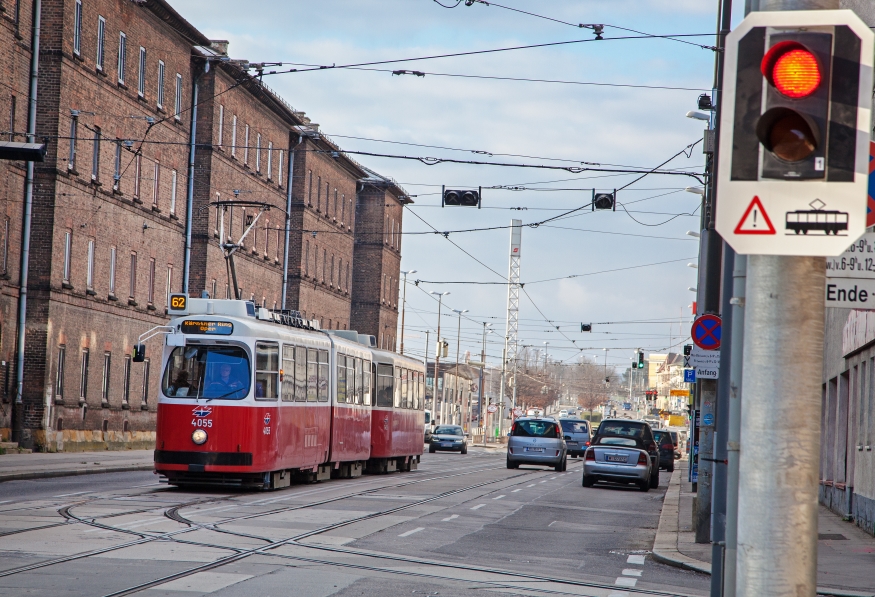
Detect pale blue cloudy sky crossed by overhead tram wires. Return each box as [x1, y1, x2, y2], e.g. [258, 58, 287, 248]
[171, 0, 741, 369]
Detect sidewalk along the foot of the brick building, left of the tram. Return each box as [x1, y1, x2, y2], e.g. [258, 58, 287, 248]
[0, 450, 154, 482]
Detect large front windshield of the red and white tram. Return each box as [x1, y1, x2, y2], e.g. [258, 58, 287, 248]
[161, 346, 251, 400]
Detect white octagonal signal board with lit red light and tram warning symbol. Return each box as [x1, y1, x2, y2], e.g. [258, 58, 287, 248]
[716, 10, 875, 256]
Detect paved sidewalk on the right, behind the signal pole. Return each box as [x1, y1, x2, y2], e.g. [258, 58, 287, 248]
[653, 461, 875, 597]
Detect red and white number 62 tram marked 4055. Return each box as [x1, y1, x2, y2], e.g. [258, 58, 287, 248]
[152, 295, 425, 488]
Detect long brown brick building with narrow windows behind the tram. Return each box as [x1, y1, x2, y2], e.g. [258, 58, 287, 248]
[0, 0, 403, 450]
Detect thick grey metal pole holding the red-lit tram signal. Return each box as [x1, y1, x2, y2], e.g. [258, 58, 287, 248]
[737, 0, 839, 597]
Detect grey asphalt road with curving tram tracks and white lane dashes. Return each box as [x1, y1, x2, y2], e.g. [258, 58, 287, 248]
[0, 448, 709, 597]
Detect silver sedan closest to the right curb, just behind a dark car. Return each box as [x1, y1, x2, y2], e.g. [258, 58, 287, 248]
[583, 436, 658, 491]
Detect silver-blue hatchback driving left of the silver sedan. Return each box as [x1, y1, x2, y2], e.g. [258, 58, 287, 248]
[507, 417, 567, 472]
